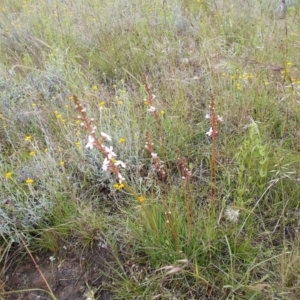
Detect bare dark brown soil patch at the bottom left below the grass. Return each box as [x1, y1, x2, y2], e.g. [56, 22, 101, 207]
[0, 244, 114, 300]
